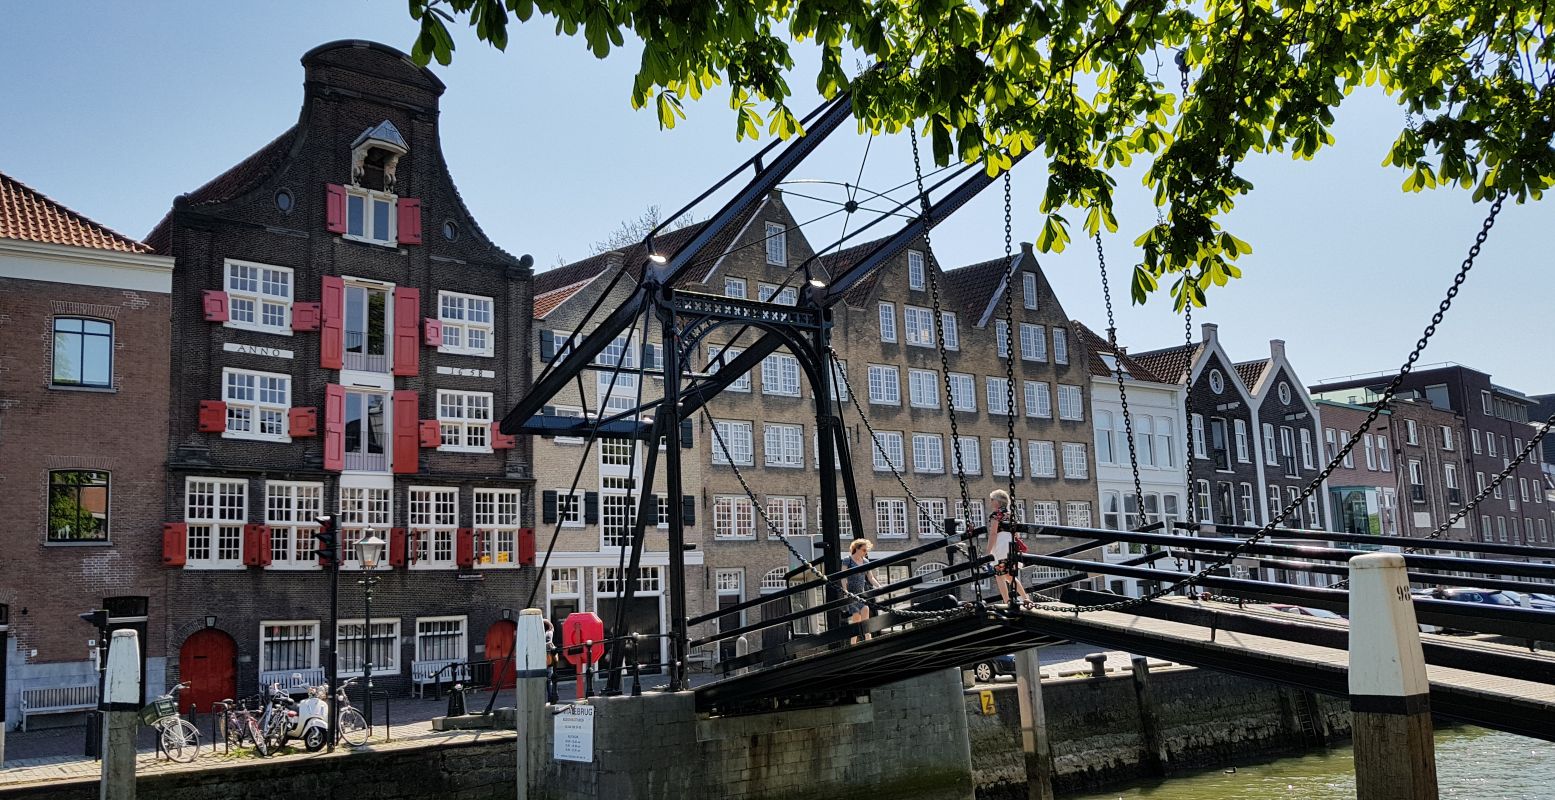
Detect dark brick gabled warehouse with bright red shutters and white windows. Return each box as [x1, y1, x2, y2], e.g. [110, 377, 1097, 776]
[148, 42, 533, 704]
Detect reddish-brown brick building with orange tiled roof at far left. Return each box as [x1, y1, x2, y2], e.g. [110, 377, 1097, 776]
[0, 174, 173, 731]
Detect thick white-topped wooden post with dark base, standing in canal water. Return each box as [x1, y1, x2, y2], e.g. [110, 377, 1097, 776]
[1350, 553, 1437, 800]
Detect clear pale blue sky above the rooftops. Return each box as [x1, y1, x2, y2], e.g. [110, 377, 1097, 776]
[0, 0, 1555, 392]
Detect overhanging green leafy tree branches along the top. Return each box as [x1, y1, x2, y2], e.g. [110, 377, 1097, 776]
[411, 0, 1555, 308]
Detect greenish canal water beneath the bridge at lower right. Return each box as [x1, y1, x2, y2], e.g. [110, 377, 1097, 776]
[1065, 727, 1555, 800]
